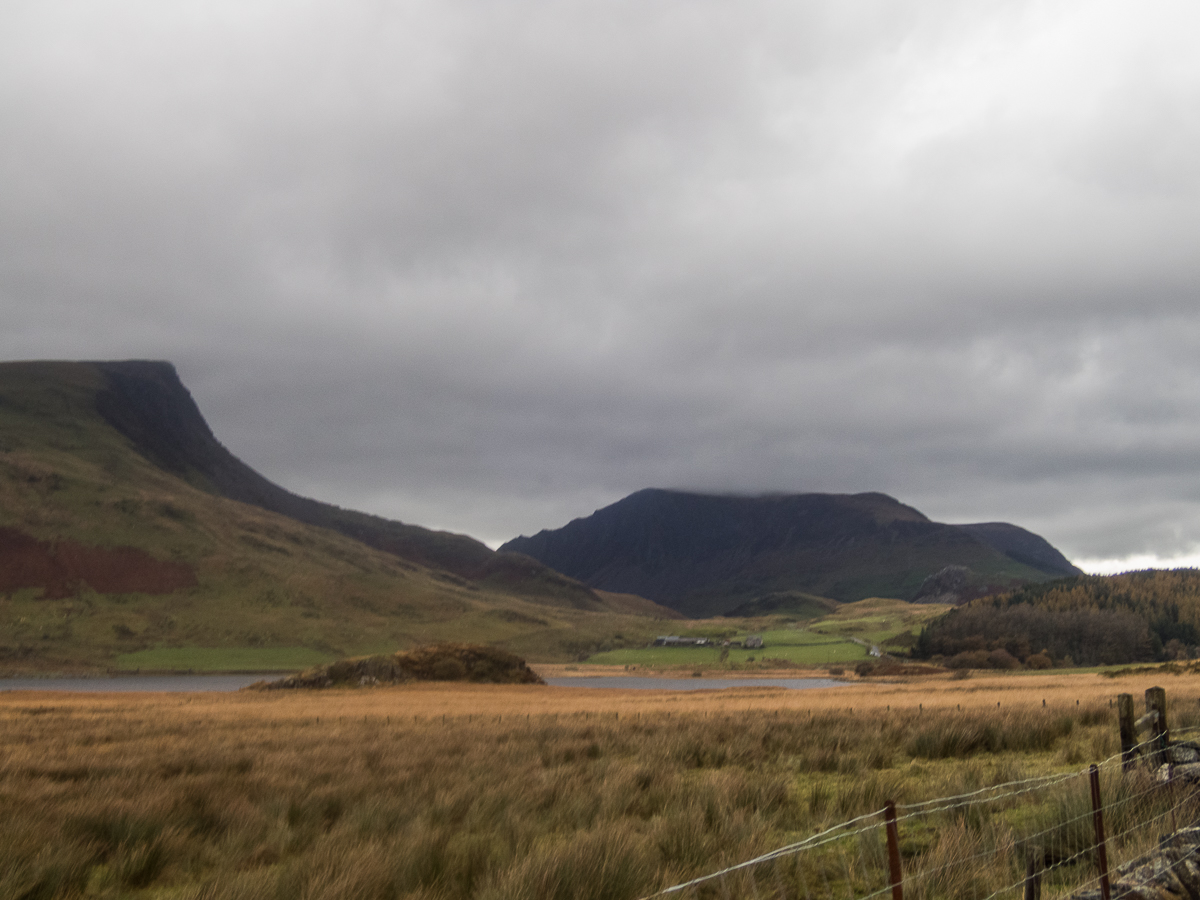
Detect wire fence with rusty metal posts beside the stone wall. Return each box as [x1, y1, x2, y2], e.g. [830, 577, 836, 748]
[644, 730, 1200, 900]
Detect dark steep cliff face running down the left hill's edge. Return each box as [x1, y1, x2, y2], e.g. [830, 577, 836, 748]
[92, 360, 600, 608]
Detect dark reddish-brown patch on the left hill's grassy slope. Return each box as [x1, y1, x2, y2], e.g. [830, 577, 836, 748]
[0, 528, 196, 600]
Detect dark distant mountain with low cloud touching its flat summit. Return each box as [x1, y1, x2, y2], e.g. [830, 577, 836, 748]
[500, 490, 1079, 616]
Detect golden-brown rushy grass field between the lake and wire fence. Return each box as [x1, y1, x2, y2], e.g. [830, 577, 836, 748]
[0, 672, 1200, 900]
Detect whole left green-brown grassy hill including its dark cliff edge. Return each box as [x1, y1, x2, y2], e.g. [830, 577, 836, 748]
[0, 361, 674, 671]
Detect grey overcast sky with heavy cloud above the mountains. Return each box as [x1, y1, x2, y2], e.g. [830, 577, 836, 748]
[0, 0, 1200, 570]
